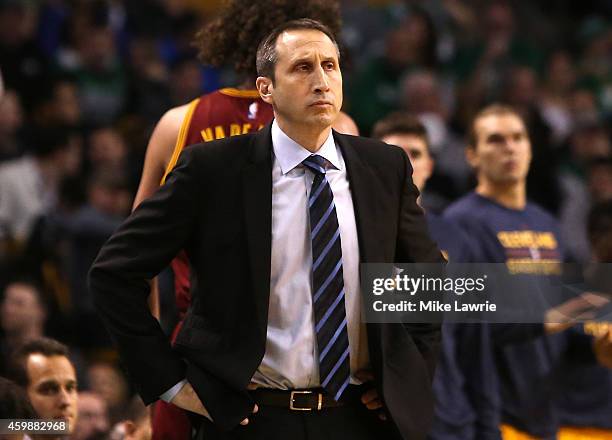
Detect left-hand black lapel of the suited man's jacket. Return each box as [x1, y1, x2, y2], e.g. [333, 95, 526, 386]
[242, 124, 272, 341]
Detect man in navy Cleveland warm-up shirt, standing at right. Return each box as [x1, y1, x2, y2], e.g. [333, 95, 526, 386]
[444, 105, 610, 440]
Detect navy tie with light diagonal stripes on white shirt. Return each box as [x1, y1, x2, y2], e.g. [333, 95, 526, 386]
[302, 155, 350, 400]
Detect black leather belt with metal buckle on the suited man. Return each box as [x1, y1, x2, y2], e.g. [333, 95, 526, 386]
[251, 385, 361, 411]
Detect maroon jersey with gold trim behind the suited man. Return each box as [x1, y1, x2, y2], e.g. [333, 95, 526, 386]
[162, 88, 274, 319]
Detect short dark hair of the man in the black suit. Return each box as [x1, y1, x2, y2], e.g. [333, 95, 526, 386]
[256, 18, 340, 81]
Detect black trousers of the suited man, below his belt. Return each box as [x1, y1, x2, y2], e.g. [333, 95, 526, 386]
[195, 403, 401, 440]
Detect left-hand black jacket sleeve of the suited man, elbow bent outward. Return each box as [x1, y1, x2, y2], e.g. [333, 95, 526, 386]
[89, 147, 202, 404]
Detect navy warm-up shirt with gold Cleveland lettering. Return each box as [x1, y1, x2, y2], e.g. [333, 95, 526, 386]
[445, 193, 566, 438]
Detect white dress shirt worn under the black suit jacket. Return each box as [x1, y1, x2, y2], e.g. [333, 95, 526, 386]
[253, 120, 369, 389]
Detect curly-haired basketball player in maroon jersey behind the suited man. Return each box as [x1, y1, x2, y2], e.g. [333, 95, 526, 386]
[134, 0, 358, 440]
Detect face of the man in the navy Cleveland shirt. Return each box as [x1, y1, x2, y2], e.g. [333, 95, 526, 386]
[466, 113, 531, 185]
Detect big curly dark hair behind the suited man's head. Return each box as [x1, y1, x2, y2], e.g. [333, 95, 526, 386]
[194, 0, 341, 78]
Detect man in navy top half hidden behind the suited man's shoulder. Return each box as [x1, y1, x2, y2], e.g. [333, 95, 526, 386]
[373, 113, 500, 440]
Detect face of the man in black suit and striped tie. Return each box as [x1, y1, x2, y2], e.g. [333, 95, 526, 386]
[258, 29, 342, 130]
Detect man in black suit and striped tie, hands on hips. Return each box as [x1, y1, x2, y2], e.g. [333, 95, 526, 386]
[90, 19, 444, 440]
